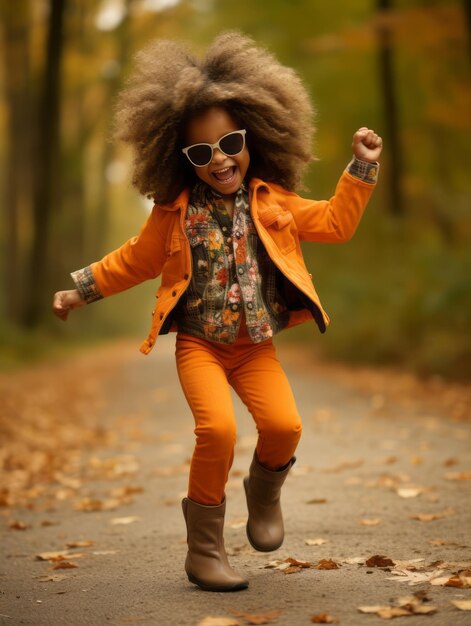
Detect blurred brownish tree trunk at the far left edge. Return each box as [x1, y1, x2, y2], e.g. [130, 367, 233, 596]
[1, 0, 32, 323]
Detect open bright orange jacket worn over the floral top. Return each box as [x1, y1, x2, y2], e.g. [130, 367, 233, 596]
[91, 171, 375, 354]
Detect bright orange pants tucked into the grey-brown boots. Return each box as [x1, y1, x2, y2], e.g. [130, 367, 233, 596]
[176, 324, 302, 505]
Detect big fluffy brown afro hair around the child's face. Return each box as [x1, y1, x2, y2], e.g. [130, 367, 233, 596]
[116, 32, 314, 204]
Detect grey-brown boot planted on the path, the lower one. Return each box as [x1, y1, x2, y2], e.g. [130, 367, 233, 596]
[182, 498, 249, 591]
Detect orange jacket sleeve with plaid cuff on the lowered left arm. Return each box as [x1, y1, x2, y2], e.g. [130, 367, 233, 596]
[72, 207, 166, 303]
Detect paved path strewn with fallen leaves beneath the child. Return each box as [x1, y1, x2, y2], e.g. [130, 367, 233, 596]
[0, 337, 471, 626]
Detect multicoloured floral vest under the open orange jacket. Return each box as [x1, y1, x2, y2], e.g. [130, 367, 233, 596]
[176, 183, 289, 344]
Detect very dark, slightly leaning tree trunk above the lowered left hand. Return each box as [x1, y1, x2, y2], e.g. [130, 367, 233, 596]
[24, 0, 65, 327]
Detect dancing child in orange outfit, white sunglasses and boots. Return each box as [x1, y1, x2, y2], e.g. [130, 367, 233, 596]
[53, 33, 382, 591]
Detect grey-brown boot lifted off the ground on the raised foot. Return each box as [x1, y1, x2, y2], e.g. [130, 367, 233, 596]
[244, 453, 296, 552]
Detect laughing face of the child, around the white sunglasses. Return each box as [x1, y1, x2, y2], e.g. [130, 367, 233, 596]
[185, 107, 250, 197]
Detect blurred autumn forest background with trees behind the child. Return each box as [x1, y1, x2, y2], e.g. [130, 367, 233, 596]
[0, 0, 471, 380]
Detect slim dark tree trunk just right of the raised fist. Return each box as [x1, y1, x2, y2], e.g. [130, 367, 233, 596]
[376, 0, 404, 216]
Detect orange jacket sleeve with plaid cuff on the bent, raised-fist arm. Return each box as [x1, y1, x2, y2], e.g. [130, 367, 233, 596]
[287, 159, 378, 243]
